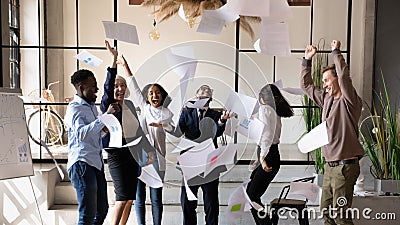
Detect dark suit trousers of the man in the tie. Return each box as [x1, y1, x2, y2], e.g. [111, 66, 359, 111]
[181, 179, 219, 225]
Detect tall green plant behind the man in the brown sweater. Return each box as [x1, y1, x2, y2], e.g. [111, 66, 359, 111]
[303, 39, 328, 186]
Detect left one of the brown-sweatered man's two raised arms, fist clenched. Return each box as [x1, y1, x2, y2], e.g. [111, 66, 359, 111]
[300, 45, 324, 107]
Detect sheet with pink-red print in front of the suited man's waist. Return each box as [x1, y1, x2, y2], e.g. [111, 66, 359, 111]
[204, 143, 237, 177]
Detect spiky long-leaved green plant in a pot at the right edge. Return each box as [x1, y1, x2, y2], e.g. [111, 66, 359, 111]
[360, 72, 400, 193]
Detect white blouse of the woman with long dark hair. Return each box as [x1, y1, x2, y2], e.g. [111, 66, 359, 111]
[258, 104, 282, 158]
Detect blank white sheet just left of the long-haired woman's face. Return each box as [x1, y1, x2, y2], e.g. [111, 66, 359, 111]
[225, 91, 257, 118]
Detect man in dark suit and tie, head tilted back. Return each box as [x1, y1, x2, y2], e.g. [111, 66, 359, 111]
[179, 85, 230, 225]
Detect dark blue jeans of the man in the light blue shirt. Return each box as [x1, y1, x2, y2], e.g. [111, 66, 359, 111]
[68, 161, 108, 225]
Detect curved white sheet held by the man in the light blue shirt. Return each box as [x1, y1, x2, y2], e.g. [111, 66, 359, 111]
[99, 113, 122, 147]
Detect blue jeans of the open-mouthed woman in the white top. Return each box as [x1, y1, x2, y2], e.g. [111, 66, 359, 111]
[135, 180, 163, 225]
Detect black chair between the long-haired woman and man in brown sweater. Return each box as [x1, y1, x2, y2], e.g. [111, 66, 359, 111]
[270, 177, 315, 225]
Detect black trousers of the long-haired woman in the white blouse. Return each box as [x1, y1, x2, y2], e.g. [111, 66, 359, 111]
[246, 145, 280, 225]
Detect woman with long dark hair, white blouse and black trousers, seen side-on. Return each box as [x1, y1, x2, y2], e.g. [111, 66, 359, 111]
[247, 84, 293, 225]
